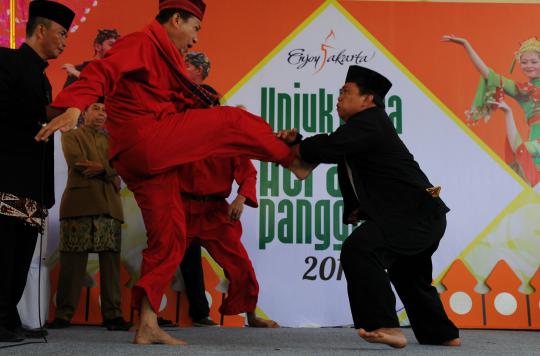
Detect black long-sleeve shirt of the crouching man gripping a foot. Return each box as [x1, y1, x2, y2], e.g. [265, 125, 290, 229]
[300, 107, 449, 252]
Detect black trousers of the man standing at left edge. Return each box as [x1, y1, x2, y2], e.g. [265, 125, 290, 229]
[0, 215, 38, 330]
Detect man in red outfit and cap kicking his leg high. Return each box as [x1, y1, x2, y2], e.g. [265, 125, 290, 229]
[36, 0, 310, 344]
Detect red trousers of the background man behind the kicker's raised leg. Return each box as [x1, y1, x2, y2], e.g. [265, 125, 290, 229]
[184, 198, 259, 315]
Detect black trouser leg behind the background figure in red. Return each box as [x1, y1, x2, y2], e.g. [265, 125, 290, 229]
[180, 243, 210, 321]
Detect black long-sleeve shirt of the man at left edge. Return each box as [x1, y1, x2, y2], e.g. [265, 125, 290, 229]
[0, 43, 54, 208]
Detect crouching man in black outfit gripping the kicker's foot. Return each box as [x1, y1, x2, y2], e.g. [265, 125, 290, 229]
[278, 66, 460, 348]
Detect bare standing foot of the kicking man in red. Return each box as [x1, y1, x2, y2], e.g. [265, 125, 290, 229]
[133, 296, 187, 345]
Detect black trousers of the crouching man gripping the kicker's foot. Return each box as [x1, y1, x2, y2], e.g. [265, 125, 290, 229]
[341, 215, 459, 344]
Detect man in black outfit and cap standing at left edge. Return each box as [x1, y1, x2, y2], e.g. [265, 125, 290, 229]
[0, 0, 75, 342]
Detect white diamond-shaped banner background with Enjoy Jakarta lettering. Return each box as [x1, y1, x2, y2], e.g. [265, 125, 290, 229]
[227, 4, 521, 326]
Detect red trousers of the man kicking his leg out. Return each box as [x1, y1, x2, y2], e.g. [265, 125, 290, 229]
[113, 107, 294, 312]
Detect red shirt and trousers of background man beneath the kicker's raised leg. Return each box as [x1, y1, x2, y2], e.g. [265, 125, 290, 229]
[178, 158, 259, 315]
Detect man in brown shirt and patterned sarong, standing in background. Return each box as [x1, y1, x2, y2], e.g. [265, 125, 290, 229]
[50, 102, 131, 330]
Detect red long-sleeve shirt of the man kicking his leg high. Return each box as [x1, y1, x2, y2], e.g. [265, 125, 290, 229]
[51, 21, 211, 158]
